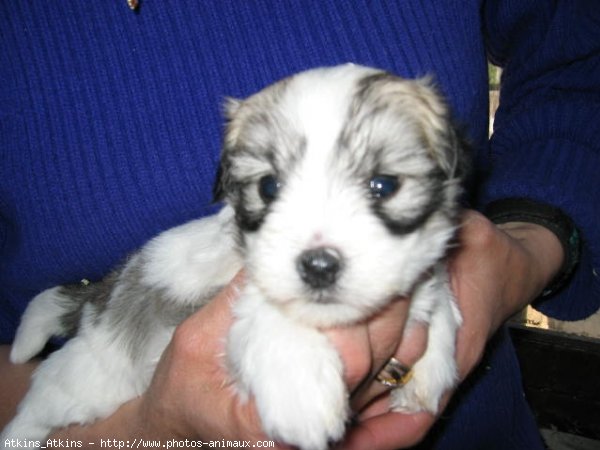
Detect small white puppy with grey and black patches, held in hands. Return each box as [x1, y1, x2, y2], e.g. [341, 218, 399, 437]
[0, 64, 464, 449]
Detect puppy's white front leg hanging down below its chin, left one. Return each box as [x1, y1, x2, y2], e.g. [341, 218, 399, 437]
[227, 285, 349, 450]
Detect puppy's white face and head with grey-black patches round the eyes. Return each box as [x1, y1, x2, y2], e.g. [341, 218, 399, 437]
[221, 65, 461, 325]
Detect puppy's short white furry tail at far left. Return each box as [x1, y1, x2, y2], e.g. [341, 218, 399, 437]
[10, 286, 90, 364]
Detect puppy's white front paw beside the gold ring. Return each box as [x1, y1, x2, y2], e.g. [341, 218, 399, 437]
[390, 354, 457, 414]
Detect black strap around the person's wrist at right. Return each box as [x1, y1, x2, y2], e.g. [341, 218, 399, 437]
[485, 198, 581, 297]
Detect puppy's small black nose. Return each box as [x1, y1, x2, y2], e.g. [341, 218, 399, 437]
[296, 247, 342, 289]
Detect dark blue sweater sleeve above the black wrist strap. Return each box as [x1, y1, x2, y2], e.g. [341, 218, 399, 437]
[479, 0, 600, 320]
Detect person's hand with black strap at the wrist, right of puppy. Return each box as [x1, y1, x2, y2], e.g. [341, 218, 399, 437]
[340, 211, 563, 449]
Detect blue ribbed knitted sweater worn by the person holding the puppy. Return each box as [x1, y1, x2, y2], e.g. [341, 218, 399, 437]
[0, 0, 600, 449]
